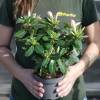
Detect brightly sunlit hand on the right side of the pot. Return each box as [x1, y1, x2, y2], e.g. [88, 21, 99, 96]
[57, 63, 82, 97]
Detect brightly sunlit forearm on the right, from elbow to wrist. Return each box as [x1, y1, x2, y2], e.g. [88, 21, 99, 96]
[76, 43, 99, 76]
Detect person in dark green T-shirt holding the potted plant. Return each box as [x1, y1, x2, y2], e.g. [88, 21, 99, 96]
[0, 0, 100, 100]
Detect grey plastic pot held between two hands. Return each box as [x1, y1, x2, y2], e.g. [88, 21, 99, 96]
[34, 75, 63, 100]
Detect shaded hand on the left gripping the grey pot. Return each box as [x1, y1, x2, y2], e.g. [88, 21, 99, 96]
[14, 68, 45, 98]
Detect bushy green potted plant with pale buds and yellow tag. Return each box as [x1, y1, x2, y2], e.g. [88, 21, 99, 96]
[16, 11, 84, 99]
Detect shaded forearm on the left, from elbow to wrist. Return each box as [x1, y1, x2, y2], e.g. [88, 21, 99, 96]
[0, 47, 21, 78]
